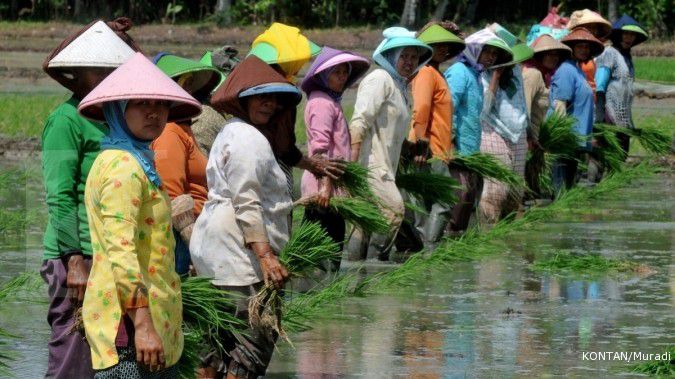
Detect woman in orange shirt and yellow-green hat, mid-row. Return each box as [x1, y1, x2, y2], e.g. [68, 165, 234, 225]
[408, 21, 464, 248]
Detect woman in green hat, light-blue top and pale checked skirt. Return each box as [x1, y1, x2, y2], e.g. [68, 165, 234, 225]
[478, 24, 534, 224]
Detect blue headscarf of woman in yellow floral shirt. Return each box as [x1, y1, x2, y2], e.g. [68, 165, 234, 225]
[101, 100, 162, 187]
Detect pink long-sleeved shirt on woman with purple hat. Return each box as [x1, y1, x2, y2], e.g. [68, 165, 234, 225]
[301, 90, 351, 196]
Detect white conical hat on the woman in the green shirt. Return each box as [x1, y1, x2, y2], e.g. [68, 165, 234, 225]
[47, 21, 135, 68]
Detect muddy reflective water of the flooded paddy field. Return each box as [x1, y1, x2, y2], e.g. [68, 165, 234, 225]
[0, 162, 675, 378]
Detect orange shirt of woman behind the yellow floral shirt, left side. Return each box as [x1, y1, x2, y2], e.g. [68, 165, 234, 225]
[151, 123, 208, 216]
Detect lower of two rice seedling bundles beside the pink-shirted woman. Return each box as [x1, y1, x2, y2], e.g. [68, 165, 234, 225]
[330, 196, 389, 233]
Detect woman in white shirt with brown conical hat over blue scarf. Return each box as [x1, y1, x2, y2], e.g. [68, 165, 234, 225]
[190, 56, 302, 378]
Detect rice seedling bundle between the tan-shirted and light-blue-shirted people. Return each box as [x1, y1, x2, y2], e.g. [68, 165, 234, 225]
[538, 112, 581, 158]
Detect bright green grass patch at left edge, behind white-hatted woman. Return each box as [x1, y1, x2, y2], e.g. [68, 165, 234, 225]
[0, 93, 68, 137]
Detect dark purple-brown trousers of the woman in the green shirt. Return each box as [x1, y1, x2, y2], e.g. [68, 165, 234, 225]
[40, 256, 94, 379]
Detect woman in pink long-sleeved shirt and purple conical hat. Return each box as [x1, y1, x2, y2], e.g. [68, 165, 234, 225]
[301, 47, 370, 269]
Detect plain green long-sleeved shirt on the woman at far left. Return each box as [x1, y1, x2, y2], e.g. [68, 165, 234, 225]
[42, 97, 108, 259]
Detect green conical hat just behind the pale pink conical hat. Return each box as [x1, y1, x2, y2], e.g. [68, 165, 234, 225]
[155, 54, 221, 97]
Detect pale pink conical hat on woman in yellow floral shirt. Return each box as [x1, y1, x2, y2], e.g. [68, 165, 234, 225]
[77, 53, 202, 121]
